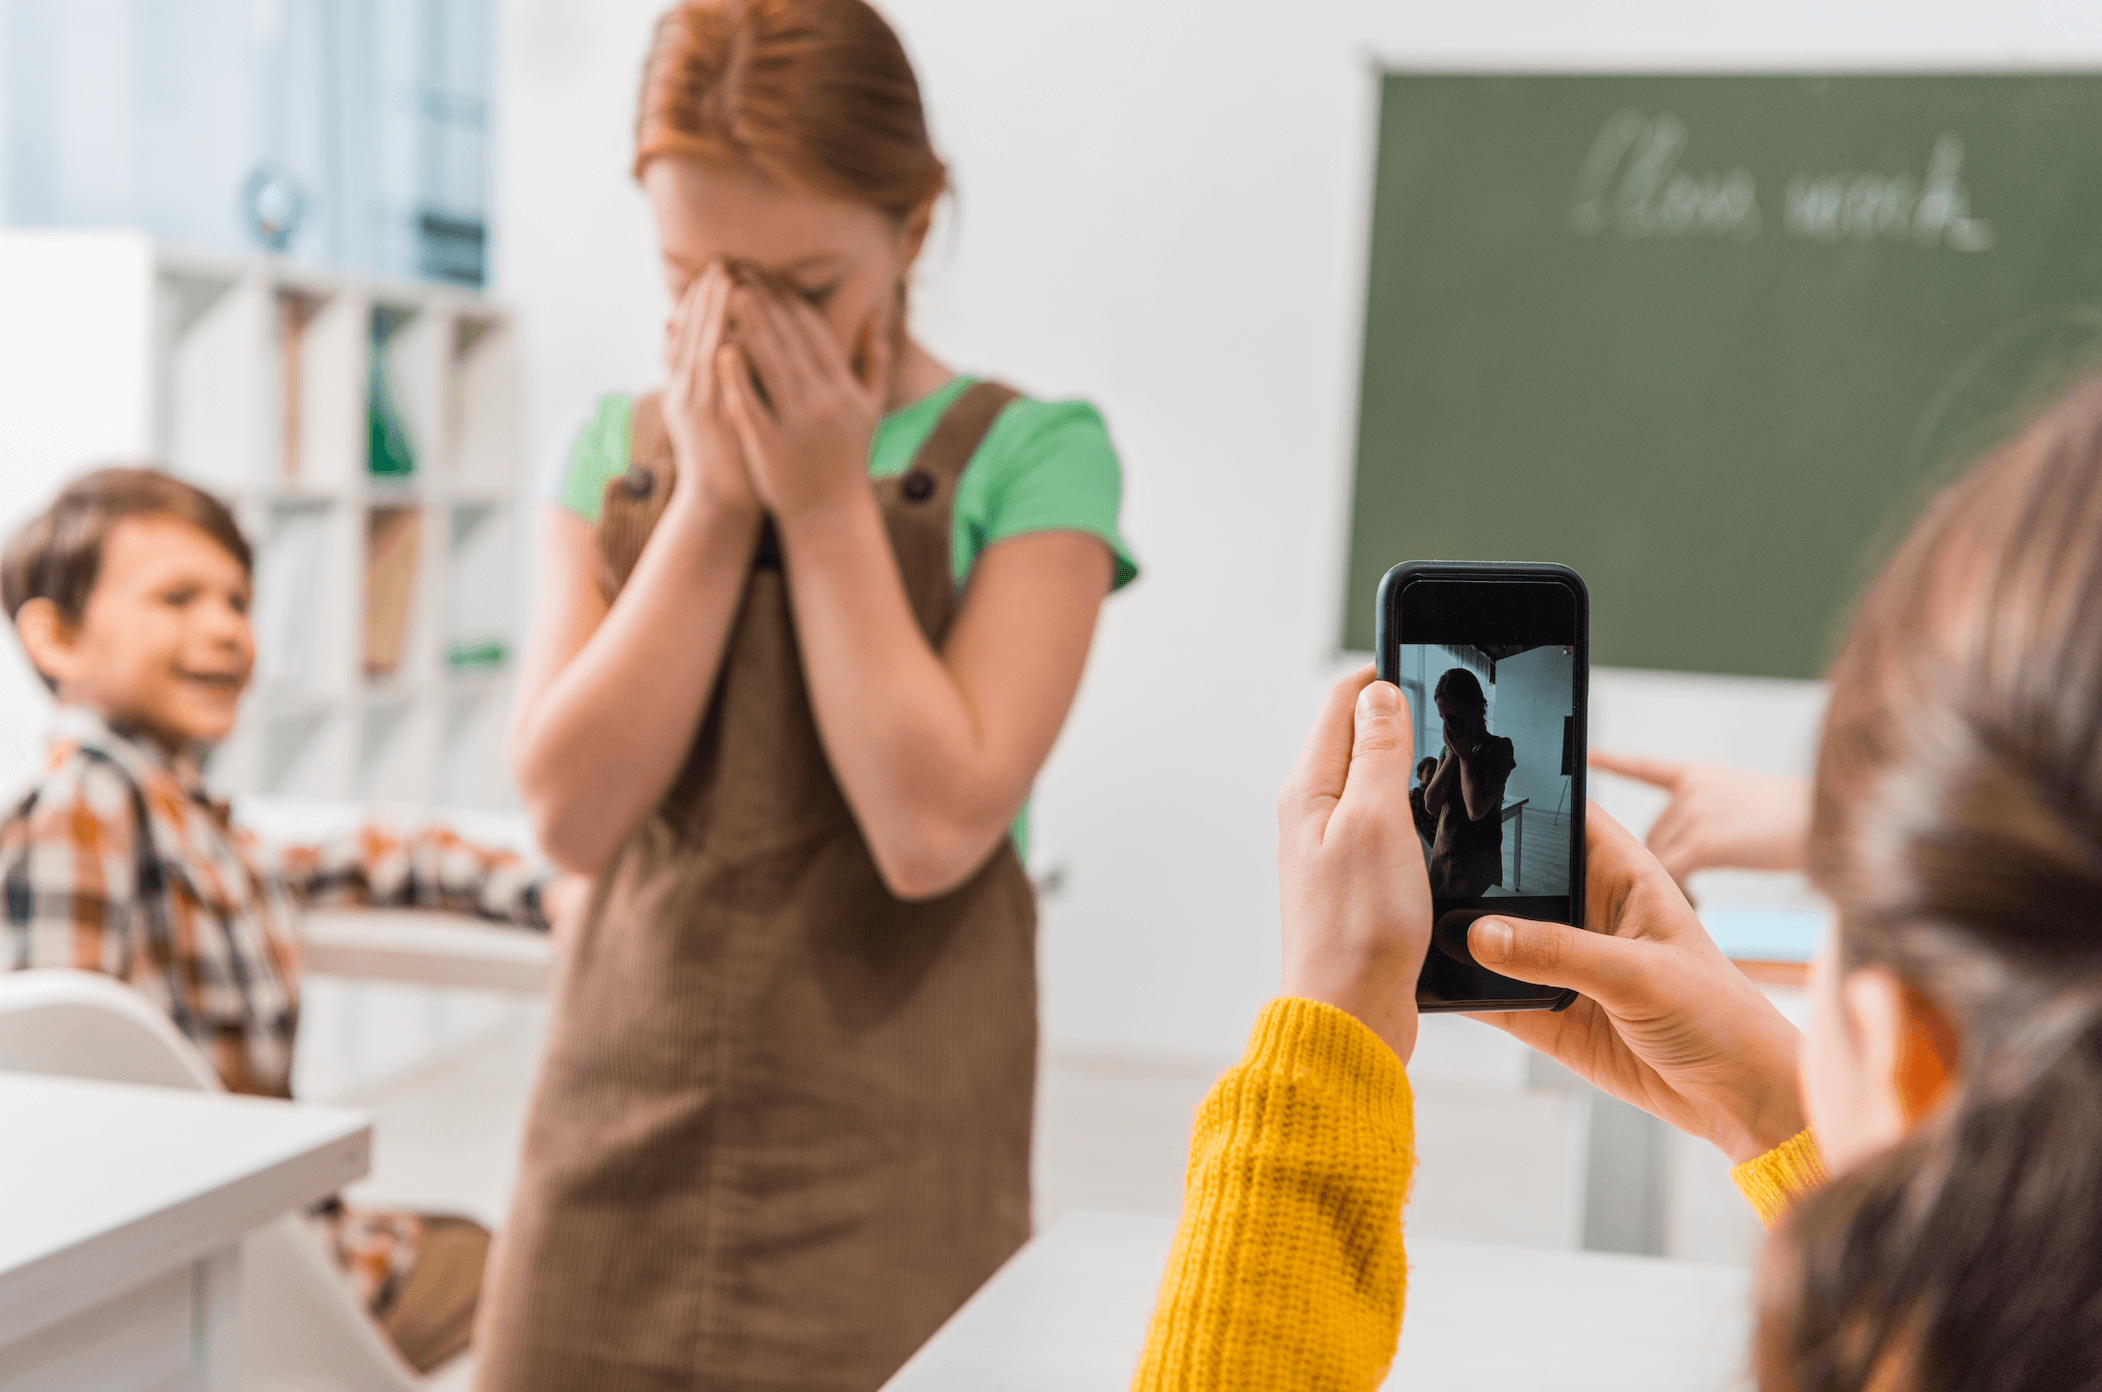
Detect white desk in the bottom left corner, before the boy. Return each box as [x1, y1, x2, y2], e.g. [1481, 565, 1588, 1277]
[0, 1072, 372, 1392]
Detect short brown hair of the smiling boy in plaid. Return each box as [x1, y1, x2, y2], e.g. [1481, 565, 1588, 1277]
[0, 469, 254, 683]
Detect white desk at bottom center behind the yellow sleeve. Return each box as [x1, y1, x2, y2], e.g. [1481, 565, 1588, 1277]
[885, 1213, 1751, 1392]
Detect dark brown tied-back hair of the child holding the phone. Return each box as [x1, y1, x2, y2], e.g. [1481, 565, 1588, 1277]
[1755, 378, 2102, 1392]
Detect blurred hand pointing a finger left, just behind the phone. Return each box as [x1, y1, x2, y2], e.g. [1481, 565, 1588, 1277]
[1591, 749, 1810, 885]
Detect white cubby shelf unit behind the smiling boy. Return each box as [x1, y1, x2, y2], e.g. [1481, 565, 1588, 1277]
[0, 231, 517, 807]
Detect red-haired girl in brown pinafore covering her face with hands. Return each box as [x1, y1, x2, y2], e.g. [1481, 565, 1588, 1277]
[481, 0, 1133, 1392]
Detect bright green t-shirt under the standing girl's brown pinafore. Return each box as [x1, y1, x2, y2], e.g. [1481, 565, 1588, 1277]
[551, 376, 1139, 860]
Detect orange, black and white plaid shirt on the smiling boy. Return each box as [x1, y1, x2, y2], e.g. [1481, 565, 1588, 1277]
[0, 707, 549, 1098]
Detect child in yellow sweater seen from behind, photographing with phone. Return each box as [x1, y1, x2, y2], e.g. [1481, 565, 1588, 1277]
[1135, 378, 2102, 1392]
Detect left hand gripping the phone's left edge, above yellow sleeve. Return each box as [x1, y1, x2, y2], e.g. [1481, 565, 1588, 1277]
[1278, 667, 1431, 1064]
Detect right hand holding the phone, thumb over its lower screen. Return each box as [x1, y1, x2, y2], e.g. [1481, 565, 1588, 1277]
[1467, 803, 1808, 1163]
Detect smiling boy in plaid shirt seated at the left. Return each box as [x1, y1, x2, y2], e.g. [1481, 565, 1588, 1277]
[0, 469, 551, 1369]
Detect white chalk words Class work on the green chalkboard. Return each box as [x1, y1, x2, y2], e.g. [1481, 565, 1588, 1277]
[1568, 107, 1995, 252]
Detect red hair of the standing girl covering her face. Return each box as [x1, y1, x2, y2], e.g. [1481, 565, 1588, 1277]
[635, 0, 948, 221]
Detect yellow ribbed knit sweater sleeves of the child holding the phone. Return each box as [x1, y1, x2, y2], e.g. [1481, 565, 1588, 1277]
[1133, 997, 1825, 1392]
